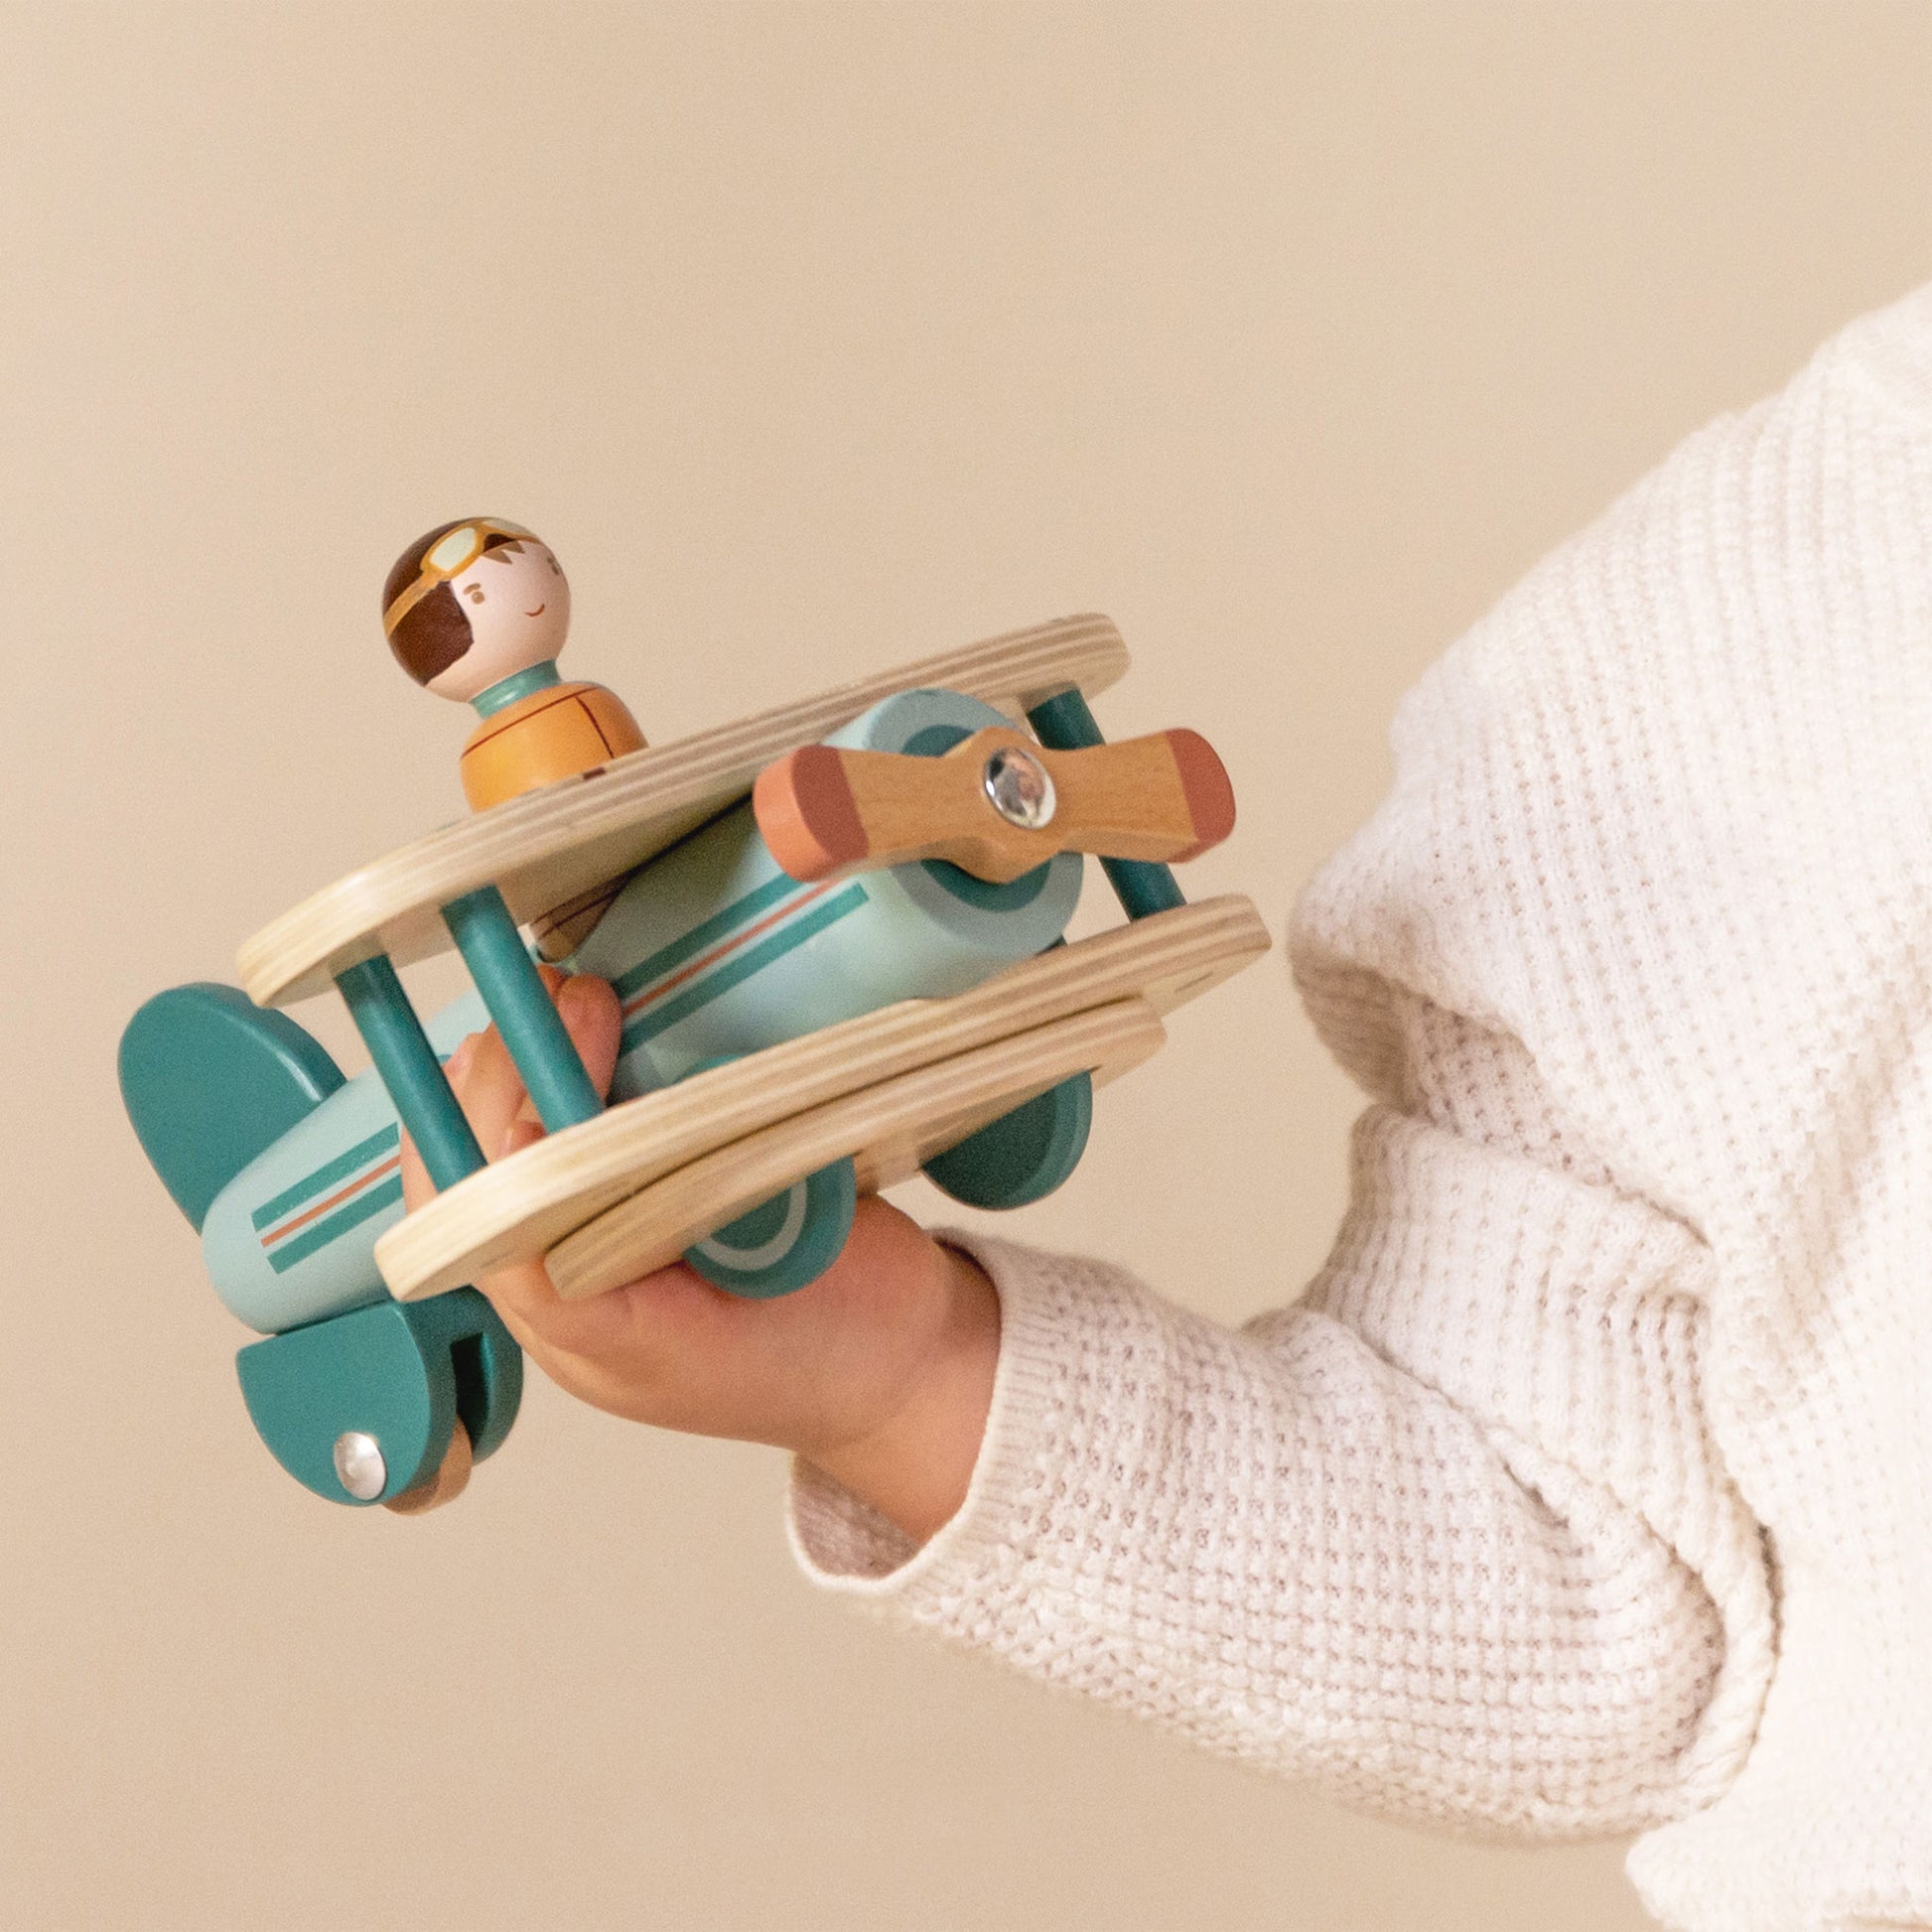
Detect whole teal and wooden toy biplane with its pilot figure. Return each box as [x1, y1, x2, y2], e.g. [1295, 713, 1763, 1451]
[120, 518, 1270, 1511]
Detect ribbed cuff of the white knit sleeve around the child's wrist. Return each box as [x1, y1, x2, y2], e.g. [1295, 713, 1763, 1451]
[788, 1229, 1127, 1621]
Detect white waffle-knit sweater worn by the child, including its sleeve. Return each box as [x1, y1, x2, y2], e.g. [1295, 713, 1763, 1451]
[792, 290, 1932, 1932]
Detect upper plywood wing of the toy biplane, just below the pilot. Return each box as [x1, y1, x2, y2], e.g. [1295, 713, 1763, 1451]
[235, 617, 1128, 1007]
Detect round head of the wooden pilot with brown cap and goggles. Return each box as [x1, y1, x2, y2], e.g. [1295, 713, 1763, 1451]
[382, 516, 570, 699]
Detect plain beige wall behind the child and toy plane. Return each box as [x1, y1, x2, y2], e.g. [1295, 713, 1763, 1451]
[0, 0, 1932, 1932]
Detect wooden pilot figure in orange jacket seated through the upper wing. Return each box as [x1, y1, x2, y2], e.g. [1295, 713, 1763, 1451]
[382, 516, 643, 958]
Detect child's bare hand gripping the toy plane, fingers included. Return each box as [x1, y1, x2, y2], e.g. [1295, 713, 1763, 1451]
[402, 970, 999, 1540]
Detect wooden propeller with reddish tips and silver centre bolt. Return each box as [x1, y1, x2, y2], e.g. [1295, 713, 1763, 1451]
[752, 725, 1234, 885]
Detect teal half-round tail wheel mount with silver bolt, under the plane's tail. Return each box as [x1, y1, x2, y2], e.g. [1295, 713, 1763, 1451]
[235, 1289, 523, 1507]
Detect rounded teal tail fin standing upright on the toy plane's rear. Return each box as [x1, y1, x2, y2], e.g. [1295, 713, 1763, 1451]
[120, 980, 342, 1233]
